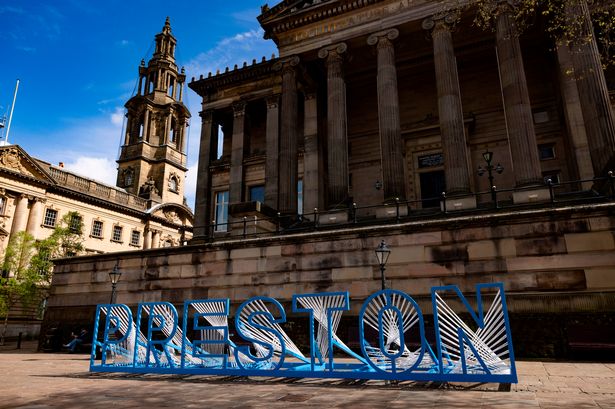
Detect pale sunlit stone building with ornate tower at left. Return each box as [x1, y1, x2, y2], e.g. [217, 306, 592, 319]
[0, 20, 193, 333]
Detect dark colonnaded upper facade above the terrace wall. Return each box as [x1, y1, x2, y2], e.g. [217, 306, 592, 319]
[189, 0, 615, 237]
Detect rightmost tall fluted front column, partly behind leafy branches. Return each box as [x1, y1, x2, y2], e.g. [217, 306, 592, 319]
[569, 0, 615, 176]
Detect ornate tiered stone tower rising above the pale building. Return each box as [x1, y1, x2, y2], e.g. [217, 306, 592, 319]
[117, 17, 190, 204]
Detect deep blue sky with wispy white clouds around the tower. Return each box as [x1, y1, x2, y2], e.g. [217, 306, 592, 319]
[0, 0, 276, 207]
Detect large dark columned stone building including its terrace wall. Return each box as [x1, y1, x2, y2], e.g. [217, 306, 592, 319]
[47, 0, 615, 356]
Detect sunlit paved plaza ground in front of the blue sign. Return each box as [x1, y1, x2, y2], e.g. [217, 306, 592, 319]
[0, 342, 615, 409]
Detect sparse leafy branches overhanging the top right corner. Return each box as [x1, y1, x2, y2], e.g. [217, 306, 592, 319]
[468, 0, 615, 68]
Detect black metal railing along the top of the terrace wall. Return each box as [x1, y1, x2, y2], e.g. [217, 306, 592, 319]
[206, 172, 615, 241]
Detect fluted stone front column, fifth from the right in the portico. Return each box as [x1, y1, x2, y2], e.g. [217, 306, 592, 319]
[318, 43, 348, 208]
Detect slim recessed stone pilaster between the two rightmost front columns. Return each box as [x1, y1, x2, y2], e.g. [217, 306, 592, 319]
[557, 45, 594, 185]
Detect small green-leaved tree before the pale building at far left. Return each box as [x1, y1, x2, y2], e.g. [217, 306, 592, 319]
[0, 212, 83, 345]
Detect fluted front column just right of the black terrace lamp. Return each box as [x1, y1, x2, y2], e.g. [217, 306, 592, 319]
[496, 0, 543, 187]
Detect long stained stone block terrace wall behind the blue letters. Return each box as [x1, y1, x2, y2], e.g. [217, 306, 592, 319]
[44, 203, 615, 356]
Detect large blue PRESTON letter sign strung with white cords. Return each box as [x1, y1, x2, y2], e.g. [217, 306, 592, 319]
[90, 283, 517, 383]
